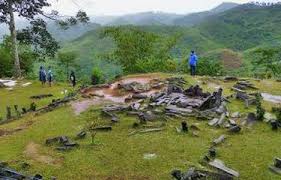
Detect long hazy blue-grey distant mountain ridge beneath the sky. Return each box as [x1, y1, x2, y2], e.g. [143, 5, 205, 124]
[0, 3, 241, 42]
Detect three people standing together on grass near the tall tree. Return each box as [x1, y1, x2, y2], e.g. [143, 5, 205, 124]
[39, 66, 76, 87]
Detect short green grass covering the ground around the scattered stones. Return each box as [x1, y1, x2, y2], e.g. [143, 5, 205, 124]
[0, 74, 281, 179]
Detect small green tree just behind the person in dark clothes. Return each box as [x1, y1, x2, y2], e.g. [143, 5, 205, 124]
[58, 52, 77, 77]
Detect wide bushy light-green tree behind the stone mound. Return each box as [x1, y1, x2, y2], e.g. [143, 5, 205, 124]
[101, 26, 179, 73]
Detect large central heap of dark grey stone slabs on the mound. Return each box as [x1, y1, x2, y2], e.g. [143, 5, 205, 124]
[102, 78, 227, 127]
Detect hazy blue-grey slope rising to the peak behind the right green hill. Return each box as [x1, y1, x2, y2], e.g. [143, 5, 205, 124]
[173, 3, 238, 26]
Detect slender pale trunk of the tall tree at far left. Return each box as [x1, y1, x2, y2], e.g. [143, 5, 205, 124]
[9, 4, 21, 78]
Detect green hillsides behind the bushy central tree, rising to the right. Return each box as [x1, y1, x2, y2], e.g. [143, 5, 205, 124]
[56, 4, 281, 81]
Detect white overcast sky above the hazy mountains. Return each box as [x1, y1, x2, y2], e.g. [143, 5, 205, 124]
[47, 0, 277, 15]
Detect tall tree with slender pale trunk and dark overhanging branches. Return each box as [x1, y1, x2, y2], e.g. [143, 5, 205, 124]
[0, 0, 89, 77]
